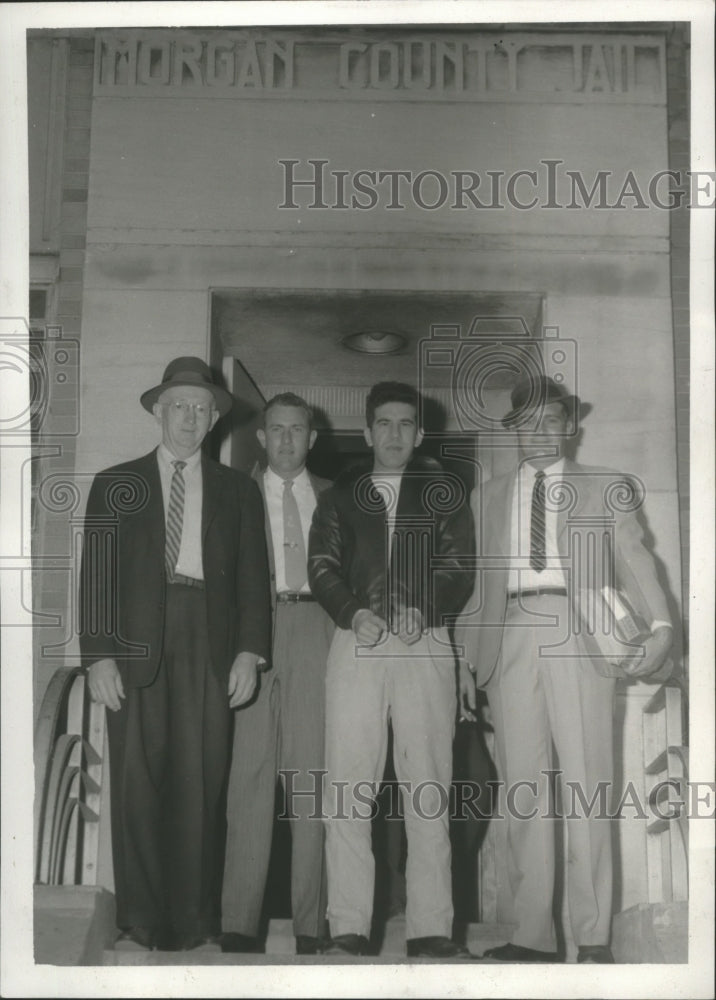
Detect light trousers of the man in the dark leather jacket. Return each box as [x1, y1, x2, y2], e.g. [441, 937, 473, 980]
[324, 629, 456, 938]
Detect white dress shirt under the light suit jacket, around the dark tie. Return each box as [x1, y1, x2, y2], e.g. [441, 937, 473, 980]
[507, 458, 566, 593]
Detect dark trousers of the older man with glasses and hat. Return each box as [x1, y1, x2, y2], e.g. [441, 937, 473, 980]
[107, 584, 230, 940]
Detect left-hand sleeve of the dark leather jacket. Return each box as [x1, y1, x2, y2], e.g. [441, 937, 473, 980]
[308, 489, 363, 629]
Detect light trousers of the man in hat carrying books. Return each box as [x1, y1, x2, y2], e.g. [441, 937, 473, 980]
[487, 595, 614, 951]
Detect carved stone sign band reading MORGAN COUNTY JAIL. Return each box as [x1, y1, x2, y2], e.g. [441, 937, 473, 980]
[95, 29, 666, 104]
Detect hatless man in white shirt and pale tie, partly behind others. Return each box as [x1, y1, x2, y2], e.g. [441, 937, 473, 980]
[222, 393, 333, 954]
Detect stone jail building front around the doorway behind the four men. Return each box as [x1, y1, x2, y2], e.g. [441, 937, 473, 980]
[30, 19, 688, 944]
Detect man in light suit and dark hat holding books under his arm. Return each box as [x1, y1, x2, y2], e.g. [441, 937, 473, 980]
[455, 375, 672, 963]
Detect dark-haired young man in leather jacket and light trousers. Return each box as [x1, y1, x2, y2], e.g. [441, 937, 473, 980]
[308, 382, 474, 960]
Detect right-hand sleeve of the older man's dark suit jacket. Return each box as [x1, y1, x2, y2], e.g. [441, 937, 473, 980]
[236, 480, 271, 660]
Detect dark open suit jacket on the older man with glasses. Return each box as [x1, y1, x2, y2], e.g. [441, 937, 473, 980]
[79, 450, 270, 687]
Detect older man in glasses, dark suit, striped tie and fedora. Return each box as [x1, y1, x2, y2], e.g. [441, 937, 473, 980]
[80, 357, 270, 950]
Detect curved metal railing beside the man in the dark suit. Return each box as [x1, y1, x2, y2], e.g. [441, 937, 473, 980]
[35, 667, 105, 885]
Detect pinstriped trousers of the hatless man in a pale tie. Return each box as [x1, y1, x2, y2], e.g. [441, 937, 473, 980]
[222, 602, 333, 937]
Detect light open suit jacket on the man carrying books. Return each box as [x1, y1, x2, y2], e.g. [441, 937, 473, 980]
[455, 459, 669, 686]
